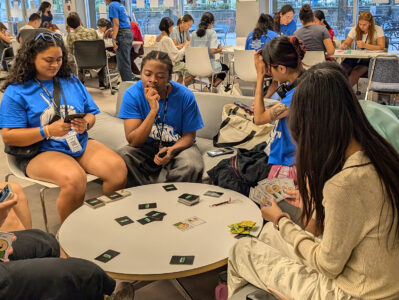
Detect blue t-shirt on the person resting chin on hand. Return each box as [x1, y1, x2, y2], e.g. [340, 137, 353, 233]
[119, 80, 204, 143]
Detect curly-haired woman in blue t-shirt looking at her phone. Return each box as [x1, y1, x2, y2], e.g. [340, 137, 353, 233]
[0, 32, 127, 222]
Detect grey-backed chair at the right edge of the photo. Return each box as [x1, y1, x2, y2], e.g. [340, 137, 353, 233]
[364, 55, 399, 102]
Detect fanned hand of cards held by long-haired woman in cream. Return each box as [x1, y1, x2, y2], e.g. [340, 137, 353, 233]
[249, 178, 295, 205]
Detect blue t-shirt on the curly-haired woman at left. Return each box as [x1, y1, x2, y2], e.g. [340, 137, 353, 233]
[0, 75, 100, 157]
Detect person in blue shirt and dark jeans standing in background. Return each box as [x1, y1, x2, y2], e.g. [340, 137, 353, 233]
[105, 0, 134, 81]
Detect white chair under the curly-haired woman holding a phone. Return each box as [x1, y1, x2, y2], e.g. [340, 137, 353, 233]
[5, 154, 98, 232]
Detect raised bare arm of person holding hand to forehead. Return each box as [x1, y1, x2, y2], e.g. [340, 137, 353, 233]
[254, 50, 288, 125]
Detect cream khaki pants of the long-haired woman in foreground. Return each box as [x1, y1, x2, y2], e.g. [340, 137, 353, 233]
[227, 222, 354, 300]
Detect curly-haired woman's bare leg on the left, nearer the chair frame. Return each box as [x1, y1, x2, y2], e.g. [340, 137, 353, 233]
[26, 151, 87, 223]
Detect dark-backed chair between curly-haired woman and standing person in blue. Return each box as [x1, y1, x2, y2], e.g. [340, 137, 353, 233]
[73, 40, 115, 95]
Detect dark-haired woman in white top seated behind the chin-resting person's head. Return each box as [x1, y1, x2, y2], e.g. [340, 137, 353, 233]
[155, 17, 194, 85]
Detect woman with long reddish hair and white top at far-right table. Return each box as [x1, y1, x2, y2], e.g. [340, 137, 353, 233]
[340, 11, 385, 86]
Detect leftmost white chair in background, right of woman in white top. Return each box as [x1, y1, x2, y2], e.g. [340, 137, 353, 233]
[183, 47, 225, 91]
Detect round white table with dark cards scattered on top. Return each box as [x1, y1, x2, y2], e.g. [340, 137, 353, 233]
[59, 182, 263, 280]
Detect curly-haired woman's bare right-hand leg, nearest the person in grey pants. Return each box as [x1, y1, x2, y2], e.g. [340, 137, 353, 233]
[77, 140, 127, 194]
